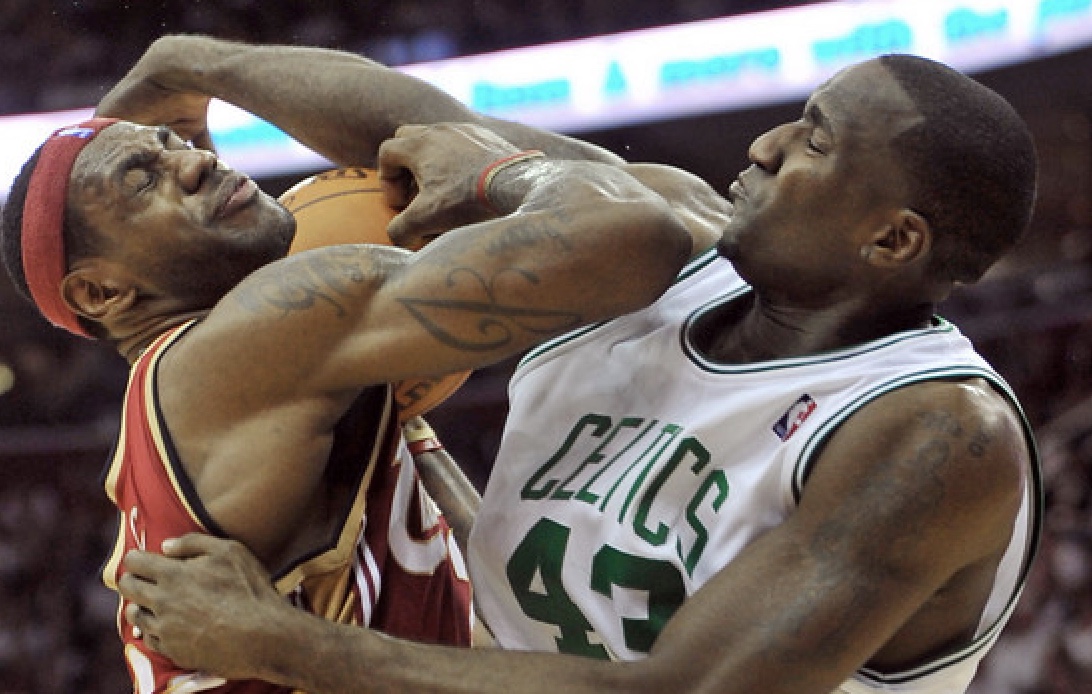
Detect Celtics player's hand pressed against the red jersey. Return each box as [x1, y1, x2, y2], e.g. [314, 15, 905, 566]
[118, 534, 296, 679]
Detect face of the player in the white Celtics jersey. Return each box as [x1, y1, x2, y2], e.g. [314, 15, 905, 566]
[720, 61, 921, 302]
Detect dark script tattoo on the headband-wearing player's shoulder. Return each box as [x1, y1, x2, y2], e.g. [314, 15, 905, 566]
[236, 248, 367, 316]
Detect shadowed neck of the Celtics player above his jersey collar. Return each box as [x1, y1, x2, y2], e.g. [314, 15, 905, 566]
[693, 294, 935, 363]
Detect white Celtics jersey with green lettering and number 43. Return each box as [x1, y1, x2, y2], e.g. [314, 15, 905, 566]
[470, 252, 1041, 694]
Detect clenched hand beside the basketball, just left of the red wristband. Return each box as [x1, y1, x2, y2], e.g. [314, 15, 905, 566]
[379, 123, 519, 250]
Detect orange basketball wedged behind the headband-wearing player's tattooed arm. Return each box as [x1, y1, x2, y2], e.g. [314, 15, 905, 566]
[281, 168, 471, 421]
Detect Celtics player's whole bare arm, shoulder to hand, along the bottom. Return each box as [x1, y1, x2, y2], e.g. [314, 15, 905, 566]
[121, 382, 1029, 694]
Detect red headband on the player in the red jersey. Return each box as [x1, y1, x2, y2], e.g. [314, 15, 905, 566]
[23, 118, 118, 337]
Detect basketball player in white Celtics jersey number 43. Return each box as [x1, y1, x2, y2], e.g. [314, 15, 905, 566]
[91, 40, 1041, 694]
